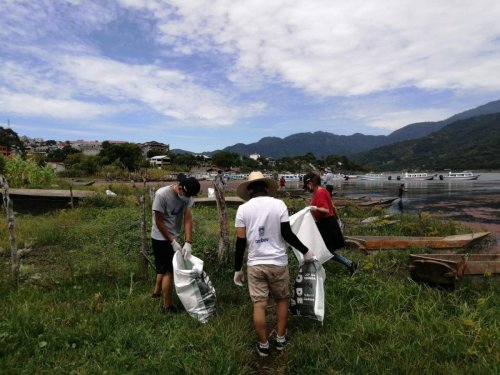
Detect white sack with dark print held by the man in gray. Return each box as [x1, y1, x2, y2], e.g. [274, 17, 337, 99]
[172, 251, 217, 323]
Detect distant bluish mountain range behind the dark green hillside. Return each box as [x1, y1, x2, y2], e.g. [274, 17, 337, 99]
[210, 100, 500, 160]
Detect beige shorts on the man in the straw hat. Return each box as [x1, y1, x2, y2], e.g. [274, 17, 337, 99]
[247, 264, 290, 303]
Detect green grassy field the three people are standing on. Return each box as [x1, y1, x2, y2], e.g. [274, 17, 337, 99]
[0, 192, 500, 374]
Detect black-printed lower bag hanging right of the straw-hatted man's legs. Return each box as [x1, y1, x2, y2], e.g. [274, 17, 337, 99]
[290, 260, 326, 322]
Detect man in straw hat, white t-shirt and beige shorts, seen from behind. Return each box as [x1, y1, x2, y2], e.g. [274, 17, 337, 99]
[234, 172, 313, 357]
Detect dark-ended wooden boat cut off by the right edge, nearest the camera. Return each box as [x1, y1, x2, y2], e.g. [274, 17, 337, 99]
[410, 254, 500, 286]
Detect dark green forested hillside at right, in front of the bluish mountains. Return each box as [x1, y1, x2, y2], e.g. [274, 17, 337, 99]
[352, 113, 500, 170]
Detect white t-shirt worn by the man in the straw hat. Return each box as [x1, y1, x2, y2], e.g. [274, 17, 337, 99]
[235, 196, 290, 266]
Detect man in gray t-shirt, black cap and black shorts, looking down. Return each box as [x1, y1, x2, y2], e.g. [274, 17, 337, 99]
[151, 177, 200, 313]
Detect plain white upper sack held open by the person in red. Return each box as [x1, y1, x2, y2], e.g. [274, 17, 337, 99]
[290, 207, 333, 265]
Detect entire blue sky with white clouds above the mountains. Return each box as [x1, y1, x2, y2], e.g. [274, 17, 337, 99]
[0, 0, 500, 152]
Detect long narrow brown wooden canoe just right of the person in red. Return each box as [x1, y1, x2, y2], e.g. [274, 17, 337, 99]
[345, 232, 490, 250]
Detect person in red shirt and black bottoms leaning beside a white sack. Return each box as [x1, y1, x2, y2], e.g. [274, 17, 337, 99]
[303, 172, 359, 276]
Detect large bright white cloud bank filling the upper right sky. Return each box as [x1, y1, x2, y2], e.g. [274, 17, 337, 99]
[122, 0, 500, 96]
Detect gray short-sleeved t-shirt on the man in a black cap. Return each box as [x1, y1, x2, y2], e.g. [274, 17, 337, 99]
[151, 185, 193, 241]
